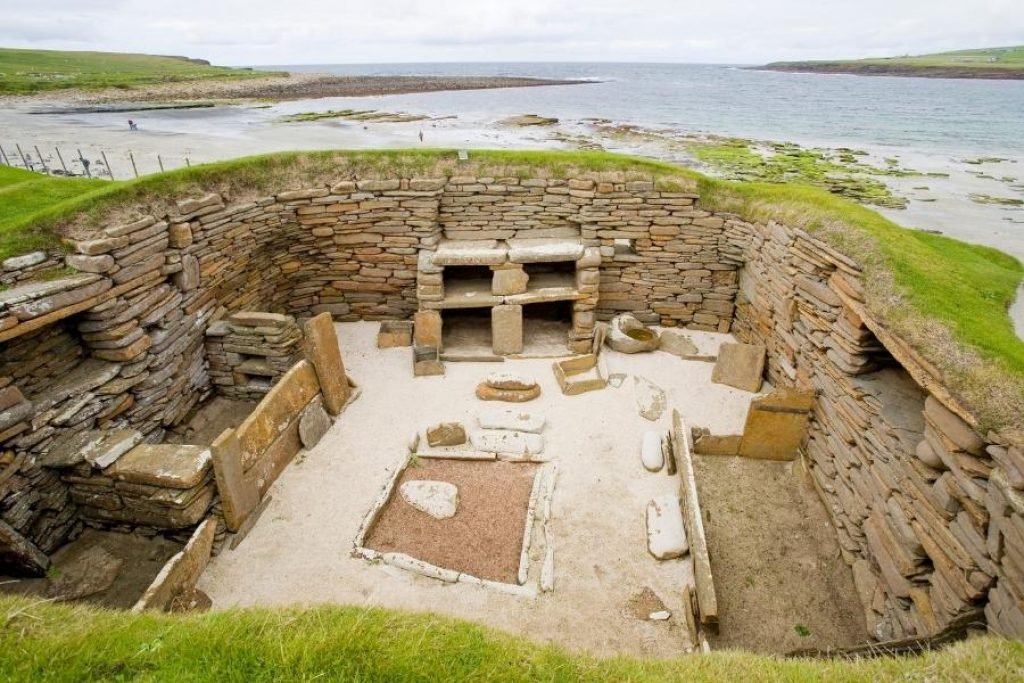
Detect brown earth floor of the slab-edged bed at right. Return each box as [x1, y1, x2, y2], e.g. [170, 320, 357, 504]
[696, 456, 867, 652]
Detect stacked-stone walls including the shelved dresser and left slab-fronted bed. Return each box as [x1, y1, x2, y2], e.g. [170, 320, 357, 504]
[0, 173, 1024, 640]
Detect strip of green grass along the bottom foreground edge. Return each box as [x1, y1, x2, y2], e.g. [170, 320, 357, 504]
[0, 598, 1024, 683]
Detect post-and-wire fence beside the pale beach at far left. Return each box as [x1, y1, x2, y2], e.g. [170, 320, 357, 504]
[0, 142, 191, 180]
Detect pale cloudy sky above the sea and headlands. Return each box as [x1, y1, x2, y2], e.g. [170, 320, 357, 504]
[0, 0, 1024, 65]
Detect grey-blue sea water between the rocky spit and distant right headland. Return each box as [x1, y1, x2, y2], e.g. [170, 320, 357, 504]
[270, 62, 1024, 157]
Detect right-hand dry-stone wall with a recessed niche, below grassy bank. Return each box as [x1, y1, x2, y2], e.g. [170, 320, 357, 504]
[726, 219, 1024, 640]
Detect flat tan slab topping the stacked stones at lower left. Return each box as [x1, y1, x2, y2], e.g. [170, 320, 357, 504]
[103, 443, 210, 488]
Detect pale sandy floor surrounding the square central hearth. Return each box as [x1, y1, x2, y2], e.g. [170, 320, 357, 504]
[200, 323, 751, 656]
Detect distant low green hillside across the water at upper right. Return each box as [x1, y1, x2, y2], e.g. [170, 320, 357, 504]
[757, 45, 1024, 79]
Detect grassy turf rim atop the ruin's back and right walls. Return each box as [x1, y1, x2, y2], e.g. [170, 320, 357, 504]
[0, 150, 1024, 429]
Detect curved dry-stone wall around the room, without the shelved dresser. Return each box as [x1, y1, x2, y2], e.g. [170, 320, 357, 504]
[0, 173, 1024, 639]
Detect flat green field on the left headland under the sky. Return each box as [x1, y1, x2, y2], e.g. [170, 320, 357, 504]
[0, 47, 282, 95]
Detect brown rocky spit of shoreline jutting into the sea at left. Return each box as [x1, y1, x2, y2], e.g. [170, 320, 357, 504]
[0, 74, 595, 106]
